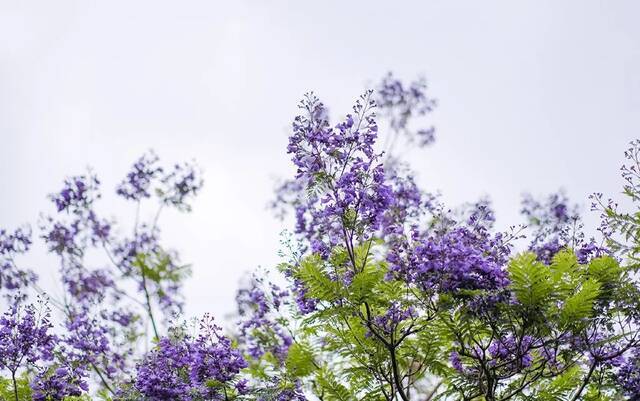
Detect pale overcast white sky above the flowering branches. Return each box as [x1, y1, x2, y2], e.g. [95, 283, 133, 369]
[0, 0, 640, 322]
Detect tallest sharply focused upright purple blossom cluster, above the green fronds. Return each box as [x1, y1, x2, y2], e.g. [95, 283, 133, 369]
[287, 91, 393, 257]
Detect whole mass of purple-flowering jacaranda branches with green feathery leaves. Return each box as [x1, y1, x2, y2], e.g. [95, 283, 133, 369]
[0, 75, 640, 401]
